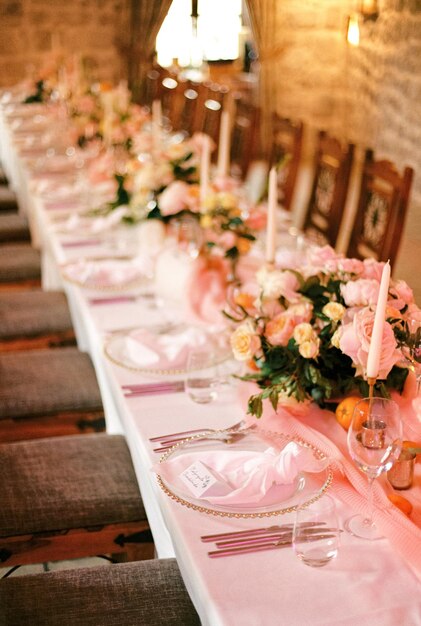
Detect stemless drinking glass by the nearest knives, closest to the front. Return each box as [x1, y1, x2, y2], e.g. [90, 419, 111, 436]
[292, 496, 341, 567]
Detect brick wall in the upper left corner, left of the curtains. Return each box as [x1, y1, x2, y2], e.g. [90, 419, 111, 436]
[0, 0, 128, 86]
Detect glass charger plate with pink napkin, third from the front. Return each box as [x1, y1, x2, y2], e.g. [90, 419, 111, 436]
[61, 256, 149, 291]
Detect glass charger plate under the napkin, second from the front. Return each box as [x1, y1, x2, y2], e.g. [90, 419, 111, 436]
[104, 322, 232, 376]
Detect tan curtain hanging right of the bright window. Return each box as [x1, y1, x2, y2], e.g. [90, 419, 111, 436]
[246, 0, 284, 152]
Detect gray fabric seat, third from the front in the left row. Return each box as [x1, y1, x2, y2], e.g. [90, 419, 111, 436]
[0, 347, 102, 422]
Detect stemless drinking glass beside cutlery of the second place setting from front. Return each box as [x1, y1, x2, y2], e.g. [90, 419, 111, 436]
[185, 348, 218, 404]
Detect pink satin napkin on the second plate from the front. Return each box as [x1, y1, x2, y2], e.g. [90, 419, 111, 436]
[125, 328, 208, 369]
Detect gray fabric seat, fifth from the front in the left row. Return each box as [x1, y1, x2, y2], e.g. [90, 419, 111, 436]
[0, 242, 41, 283]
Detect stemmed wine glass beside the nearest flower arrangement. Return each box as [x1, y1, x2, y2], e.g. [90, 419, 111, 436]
[345, 398, 402, 539]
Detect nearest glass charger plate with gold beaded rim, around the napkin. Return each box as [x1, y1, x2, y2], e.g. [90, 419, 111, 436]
[157, 428, 333, 518]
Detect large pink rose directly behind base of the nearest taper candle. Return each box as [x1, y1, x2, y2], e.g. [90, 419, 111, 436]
[339, 307, 402, 379]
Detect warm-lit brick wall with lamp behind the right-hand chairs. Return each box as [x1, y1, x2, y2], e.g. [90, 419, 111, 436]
[256, 0, 421, 304]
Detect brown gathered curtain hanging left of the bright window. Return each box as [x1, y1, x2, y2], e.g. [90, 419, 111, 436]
[118, 0, 172, 100]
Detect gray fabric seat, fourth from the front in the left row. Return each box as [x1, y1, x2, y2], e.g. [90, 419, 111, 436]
[0, 289, 73, 341]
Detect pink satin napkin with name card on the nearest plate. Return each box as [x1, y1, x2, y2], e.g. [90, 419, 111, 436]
[154, 441, 328, 506]
